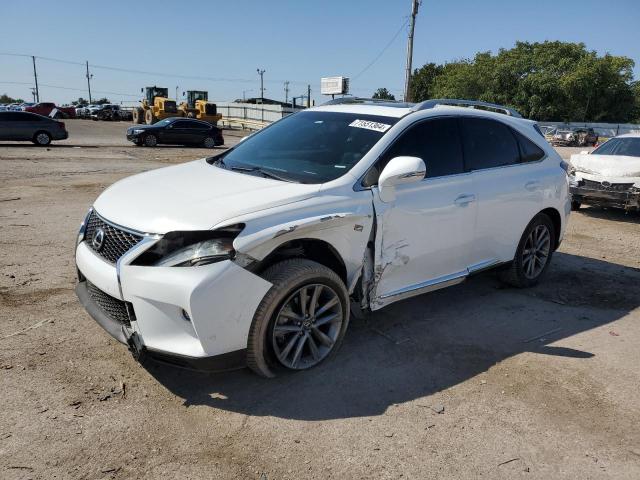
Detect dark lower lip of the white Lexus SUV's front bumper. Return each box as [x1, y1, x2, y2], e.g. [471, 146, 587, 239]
[76, 281, 247, 372]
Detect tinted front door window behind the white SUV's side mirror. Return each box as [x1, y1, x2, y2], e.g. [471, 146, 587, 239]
[379, 118, 464, 178]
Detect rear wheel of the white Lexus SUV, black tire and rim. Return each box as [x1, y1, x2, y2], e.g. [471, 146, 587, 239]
[499, 213, 556, 288]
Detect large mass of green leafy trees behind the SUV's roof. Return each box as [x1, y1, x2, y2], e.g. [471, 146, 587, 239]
[412, 41, 639, 122]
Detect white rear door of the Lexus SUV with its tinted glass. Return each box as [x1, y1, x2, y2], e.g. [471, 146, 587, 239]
[460, 117, 545, 270]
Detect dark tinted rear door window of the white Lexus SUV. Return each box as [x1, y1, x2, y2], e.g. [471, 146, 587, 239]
[461, 117, 520, 170]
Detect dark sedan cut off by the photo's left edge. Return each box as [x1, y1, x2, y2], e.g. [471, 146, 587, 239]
[0, 112, 69, 146]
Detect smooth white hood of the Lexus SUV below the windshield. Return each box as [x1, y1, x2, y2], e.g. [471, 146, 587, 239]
[94, 159, 320, 234]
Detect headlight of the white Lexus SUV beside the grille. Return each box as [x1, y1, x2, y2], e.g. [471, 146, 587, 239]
[133, 225, 244, 267]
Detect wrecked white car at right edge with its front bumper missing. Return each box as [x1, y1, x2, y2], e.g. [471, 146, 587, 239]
[570, 133, 640, 211]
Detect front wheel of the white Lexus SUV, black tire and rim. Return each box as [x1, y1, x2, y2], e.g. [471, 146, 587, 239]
[247, 258, 349, 377]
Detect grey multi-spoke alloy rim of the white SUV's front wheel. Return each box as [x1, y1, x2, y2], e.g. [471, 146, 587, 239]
[272, 284, 343, 370]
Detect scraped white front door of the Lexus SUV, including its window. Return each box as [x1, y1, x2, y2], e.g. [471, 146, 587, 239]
[371, 117, 477, 310]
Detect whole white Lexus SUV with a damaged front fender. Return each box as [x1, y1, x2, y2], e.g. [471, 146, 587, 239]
[76, 99, 570, 376]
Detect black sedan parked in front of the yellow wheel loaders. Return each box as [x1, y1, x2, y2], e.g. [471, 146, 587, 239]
[127, 117, 224, 148]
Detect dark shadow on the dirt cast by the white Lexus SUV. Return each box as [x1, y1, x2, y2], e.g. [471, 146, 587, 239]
[147, 253, 640, 420]
